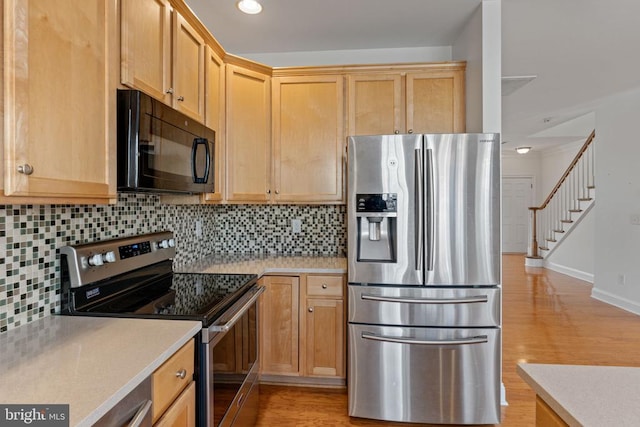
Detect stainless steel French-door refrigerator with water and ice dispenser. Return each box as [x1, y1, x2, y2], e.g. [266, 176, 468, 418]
[347, 134, 502, 424]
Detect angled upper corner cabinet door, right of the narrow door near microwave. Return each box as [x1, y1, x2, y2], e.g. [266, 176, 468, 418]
[226, 65, 271, 202]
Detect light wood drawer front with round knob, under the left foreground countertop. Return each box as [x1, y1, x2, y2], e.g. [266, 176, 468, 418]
[151, 340, 194, 422]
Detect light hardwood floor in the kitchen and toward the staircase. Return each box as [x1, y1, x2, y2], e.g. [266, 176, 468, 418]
[257, 255, 640, 427]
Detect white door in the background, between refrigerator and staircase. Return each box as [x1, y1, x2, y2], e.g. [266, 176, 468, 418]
[502, 176, 533, 253]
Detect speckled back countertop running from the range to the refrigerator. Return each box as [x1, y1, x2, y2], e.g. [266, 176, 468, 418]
[175, 254, 347, 276]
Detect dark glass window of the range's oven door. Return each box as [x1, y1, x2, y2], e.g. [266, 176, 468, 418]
[212, 304, 258, 426]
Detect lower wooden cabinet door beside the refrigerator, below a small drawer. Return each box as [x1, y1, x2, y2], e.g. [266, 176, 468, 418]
[305, 298, 345, 378]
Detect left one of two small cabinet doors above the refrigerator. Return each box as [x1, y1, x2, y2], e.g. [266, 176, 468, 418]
[347, 73, 405, 135]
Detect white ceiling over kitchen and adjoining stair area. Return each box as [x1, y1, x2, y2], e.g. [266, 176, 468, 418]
[186, 0, 640, 154]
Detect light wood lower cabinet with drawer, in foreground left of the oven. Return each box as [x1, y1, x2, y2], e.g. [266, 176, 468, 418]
[151, 340, 196, 427]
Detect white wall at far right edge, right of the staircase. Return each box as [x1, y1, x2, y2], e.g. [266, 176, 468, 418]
[593, 87, 640, 314]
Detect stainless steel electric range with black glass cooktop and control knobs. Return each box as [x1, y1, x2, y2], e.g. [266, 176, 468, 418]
[60, 232, 264, 426]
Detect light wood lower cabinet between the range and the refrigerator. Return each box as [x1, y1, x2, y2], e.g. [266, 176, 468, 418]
[260, 274, 346, 385]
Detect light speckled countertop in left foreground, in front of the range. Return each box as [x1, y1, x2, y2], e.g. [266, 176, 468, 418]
[0, 315, 202, 426]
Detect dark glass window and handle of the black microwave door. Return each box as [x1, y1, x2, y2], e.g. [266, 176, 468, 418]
[138, 115, 212, 191]
